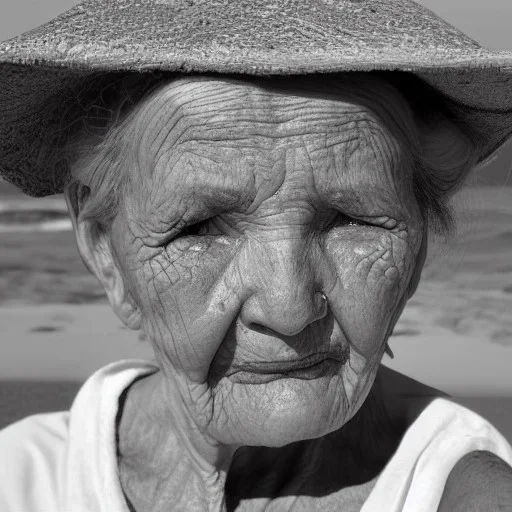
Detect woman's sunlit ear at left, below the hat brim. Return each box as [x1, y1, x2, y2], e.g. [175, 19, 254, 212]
[64, 182, 142, 330]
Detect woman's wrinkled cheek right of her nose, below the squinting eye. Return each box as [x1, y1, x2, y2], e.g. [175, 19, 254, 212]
[325, 227, 416, 358]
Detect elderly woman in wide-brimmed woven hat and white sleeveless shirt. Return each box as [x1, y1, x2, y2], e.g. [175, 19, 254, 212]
[0, 0, 512, 512]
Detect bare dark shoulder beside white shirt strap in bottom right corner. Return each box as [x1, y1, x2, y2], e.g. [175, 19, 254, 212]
[438, 451, 512, 512]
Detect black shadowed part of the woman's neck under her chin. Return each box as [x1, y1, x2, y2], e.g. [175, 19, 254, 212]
[226, 378, 407, 510]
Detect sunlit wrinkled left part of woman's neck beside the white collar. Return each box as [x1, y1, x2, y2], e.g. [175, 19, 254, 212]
[118, 372, 237, 511]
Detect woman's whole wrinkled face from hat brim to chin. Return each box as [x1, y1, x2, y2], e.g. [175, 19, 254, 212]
[107, 78, 424, 446]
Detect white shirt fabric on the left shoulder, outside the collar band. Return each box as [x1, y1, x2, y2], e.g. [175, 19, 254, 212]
[0, 412, 69, 512]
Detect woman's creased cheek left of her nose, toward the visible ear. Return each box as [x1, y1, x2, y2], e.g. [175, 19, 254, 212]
[131, 236, 235, 381]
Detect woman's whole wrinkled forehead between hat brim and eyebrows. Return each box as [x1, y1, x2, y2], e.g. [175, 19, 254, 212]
[125, 77, 416, 226]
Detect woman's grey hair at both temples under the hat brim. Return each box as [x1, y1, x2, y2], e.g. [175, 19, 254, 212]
[65, 73, 477, 235]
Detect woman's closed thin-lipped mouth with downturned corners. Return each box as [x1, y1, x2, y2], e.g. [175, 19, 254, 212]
[229, 352, 348, 384]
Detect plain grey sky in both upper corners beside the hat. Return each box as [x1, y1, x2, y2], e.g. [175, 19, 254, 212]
[0, 0, 512, 49]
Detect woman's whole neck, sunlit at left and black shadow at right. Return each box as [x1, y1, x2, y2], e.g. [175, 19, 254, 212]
[118, 366, 416, 512]
